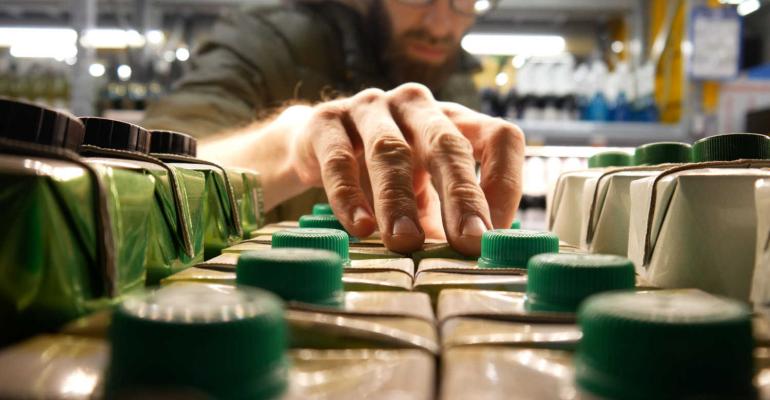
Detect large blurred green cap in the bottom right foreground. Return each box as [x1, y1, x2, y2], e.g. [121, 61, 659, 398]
[575, 291, 755, 400]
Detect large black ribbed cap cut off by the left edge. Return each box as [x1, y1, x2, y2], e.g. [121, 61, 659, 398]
[0, 98, 85, 151]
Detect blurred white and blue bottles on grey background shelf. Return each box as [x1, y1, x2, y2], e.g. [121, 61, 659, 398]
[481, 55, 688, 146]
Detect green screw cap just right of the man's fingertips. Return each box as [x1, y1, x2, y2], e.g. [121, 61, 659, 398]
[478, 229, 559, 268]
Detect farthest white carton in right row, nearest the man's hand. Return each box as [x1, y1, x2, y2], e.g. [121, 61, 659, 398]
[546, 168, 604, 246]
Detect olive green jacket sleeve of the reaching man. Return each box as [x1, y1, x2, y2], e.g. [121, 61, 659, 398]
[143, 6, 341, 137]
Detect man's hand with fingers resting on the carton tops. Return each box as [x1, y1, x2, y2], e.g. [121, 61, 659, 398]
[284, 84, 524, 255]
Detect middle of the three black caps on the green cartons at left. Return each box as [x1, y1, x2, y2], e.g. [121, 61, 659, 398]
[80, 117, 150, 154]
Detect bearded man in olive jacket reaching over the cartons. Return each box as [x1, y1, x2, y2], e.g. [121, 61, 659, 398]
[144, 0, 524, 255]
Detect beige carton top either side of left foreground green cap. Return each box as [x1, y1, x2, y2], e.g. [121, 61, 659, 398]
[0, 335, 435, 400]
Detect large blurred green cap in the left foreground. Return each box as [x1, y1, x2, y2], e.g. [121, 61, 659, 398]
[105, 284, 288, 399]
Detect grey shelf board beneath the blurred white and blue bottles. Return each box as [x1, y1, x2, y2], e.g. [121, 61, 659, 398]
[511, 120, 690, 147]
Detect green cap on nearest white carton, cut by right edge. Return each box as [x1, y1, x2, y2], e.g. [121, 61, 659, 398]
[692, 133, 770, 162]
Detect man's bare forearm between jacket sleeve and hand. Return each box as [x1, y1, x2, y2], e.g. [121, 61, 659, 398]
[198, 106, 312, 210]
